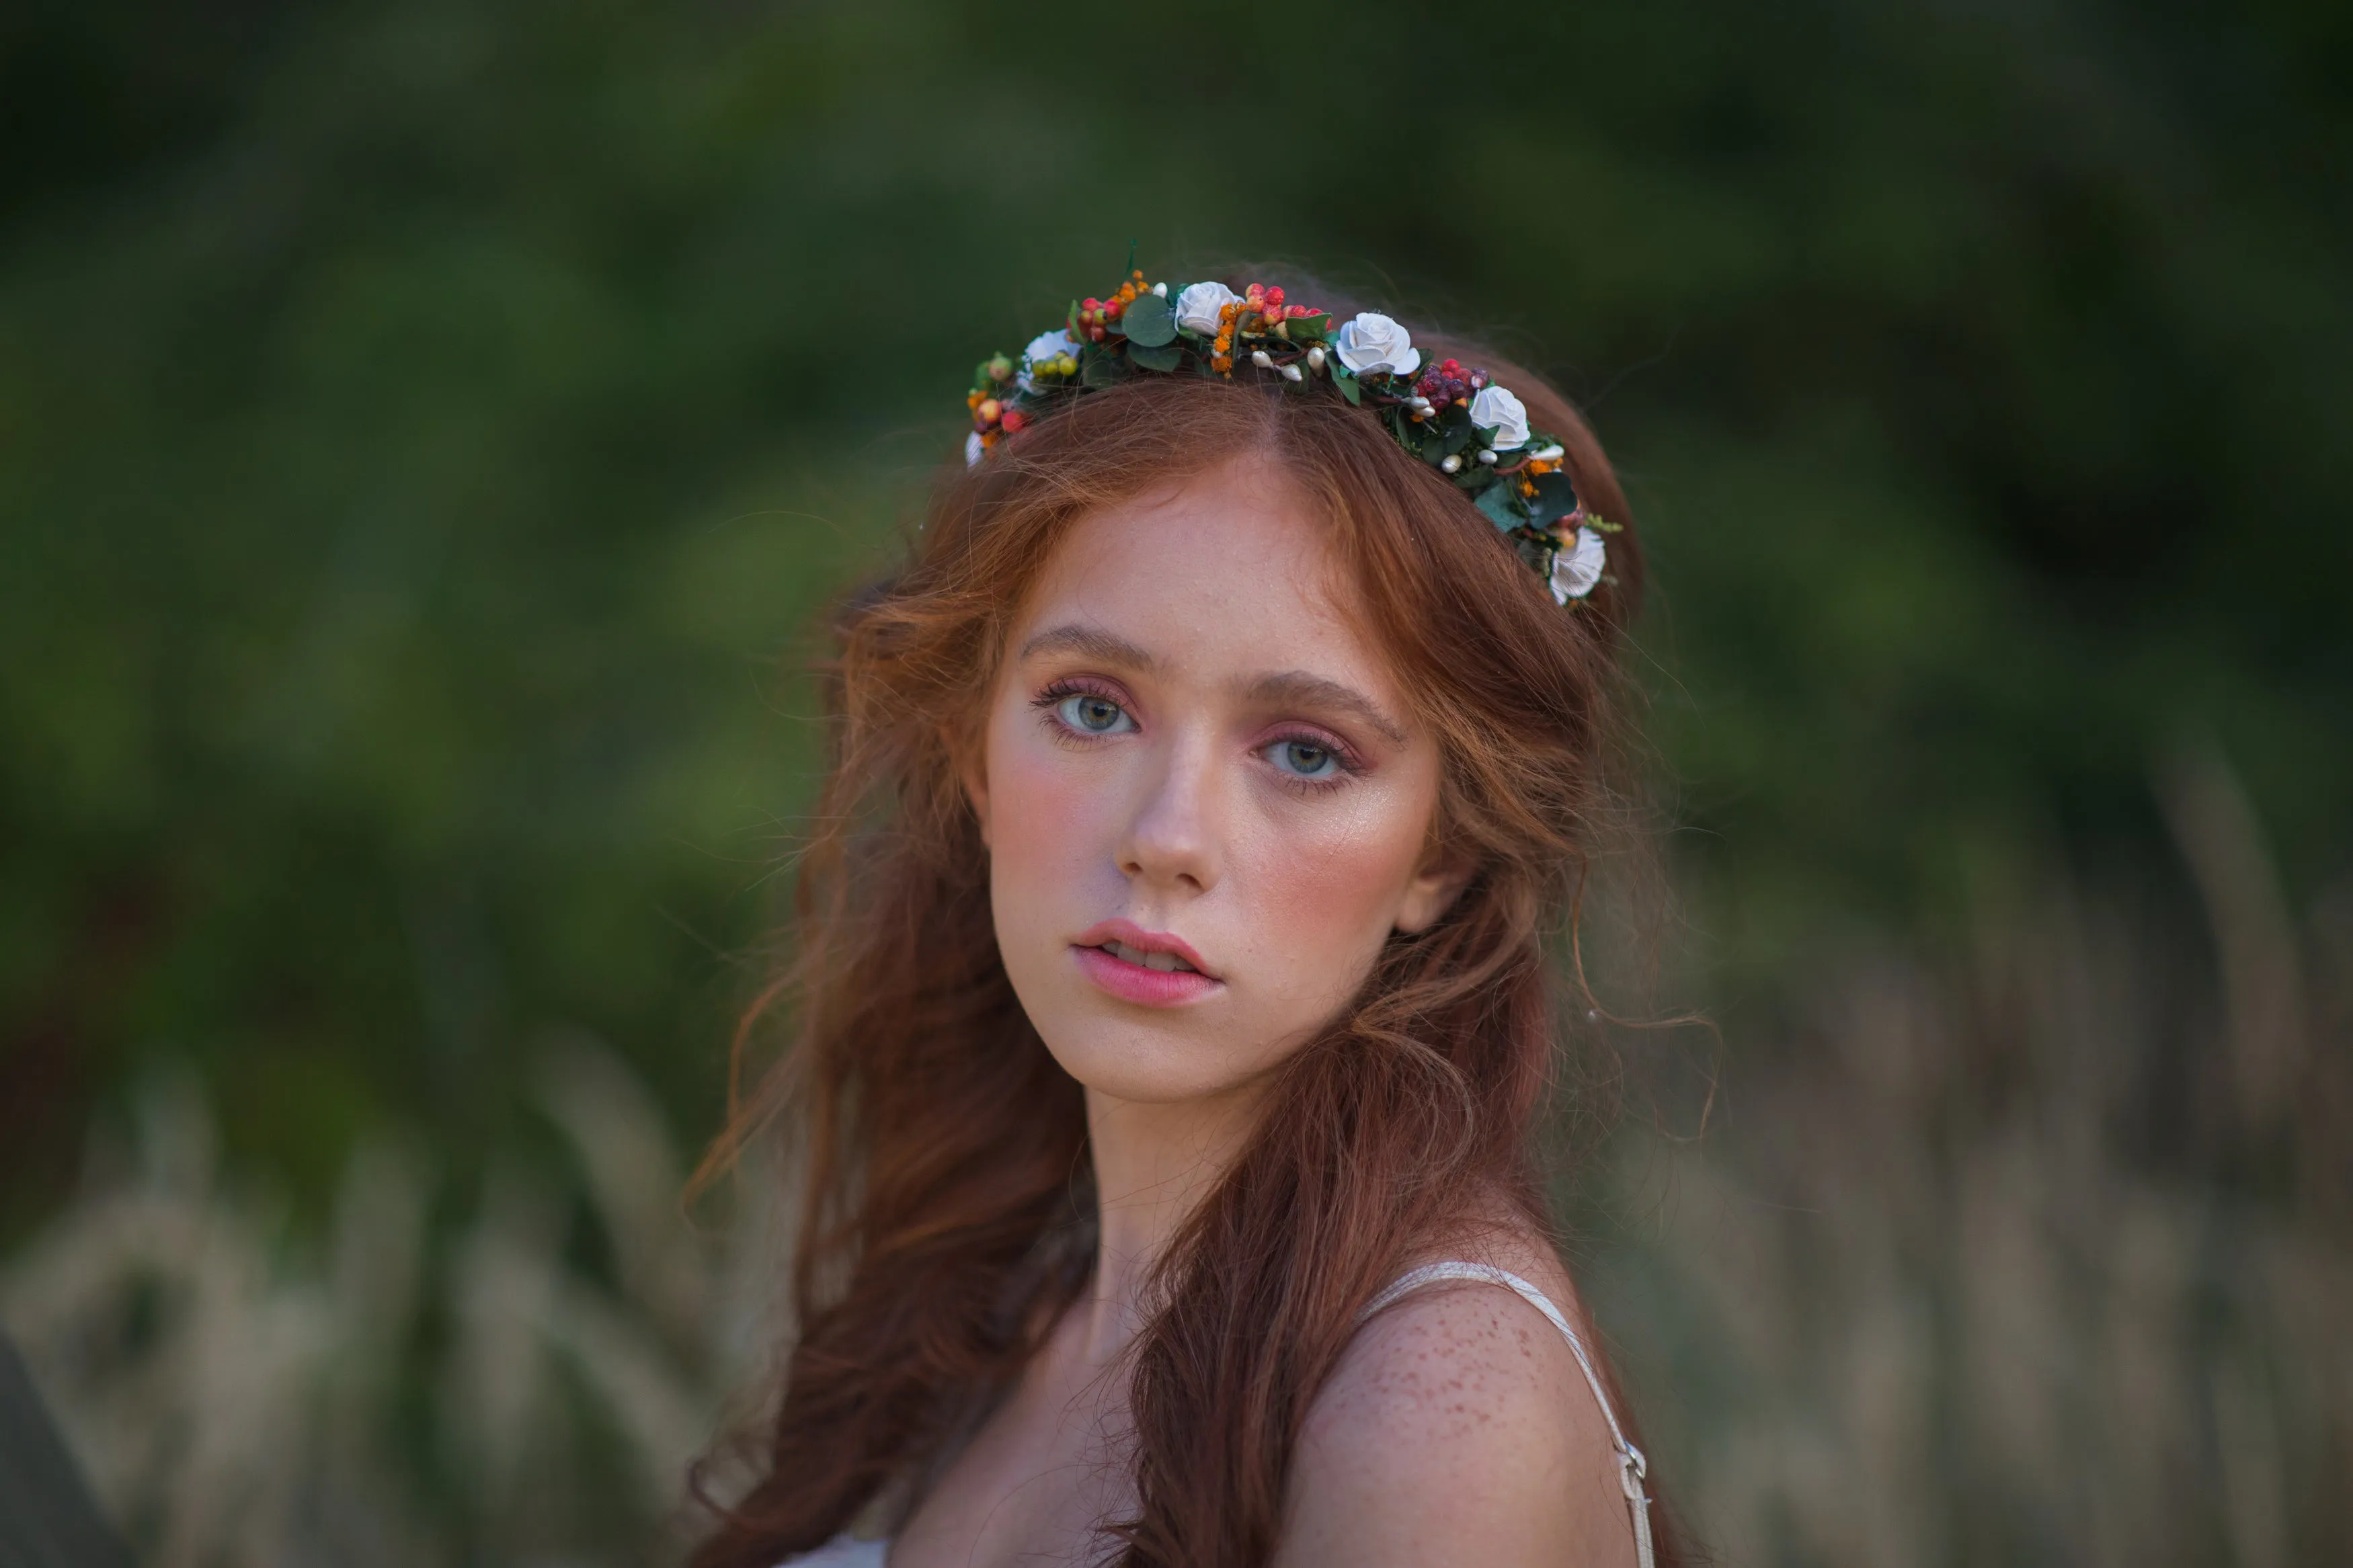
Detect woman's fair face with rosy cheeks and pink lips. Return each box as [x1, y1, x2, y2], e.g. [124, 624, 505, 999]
[967, 463, 1462, 1102]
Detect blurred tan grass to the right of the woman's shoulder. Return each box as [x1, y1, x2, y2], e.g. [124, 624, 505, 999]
[1589, 745, 2353, 1566]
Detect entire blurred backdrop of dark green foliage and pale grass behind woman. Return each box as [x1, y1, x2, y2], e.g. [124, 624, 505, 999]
[0, 0, 2353, 1563]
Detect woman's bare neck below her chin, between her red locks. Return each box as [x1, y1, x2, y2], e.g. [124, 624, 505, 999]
[1080, 1088, 1259, 1364]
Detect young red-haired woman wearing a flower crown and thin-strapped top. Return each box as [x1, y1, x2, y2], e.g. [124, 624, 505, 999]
[694, 273, 1673, 1568]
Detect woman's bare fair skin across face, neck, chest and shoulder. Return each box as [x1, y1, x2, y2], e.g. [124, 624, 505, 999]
[889, 466, 1633, 1568]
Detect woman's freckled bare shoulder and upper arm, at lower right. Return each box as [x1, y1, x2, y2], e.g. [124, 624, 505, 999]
[1278, 1234, 1636, 1568]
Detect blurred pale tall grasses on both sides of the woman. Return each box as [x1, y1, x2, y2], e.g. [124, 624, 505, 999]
[13, 752, 2353, 1568]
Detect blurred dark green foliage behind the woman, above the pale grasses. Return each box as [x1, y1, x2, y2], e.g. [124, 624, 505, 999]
[0, 0, 2353, 1419]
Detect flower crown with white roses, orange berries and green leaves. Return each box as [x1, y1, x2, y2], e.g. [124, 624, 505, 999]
[965, 273, 1619, 604]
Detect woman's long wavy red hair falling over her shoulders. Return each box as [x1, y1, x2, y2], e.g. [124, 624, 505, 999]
[692, 297, 1675, 1568]
